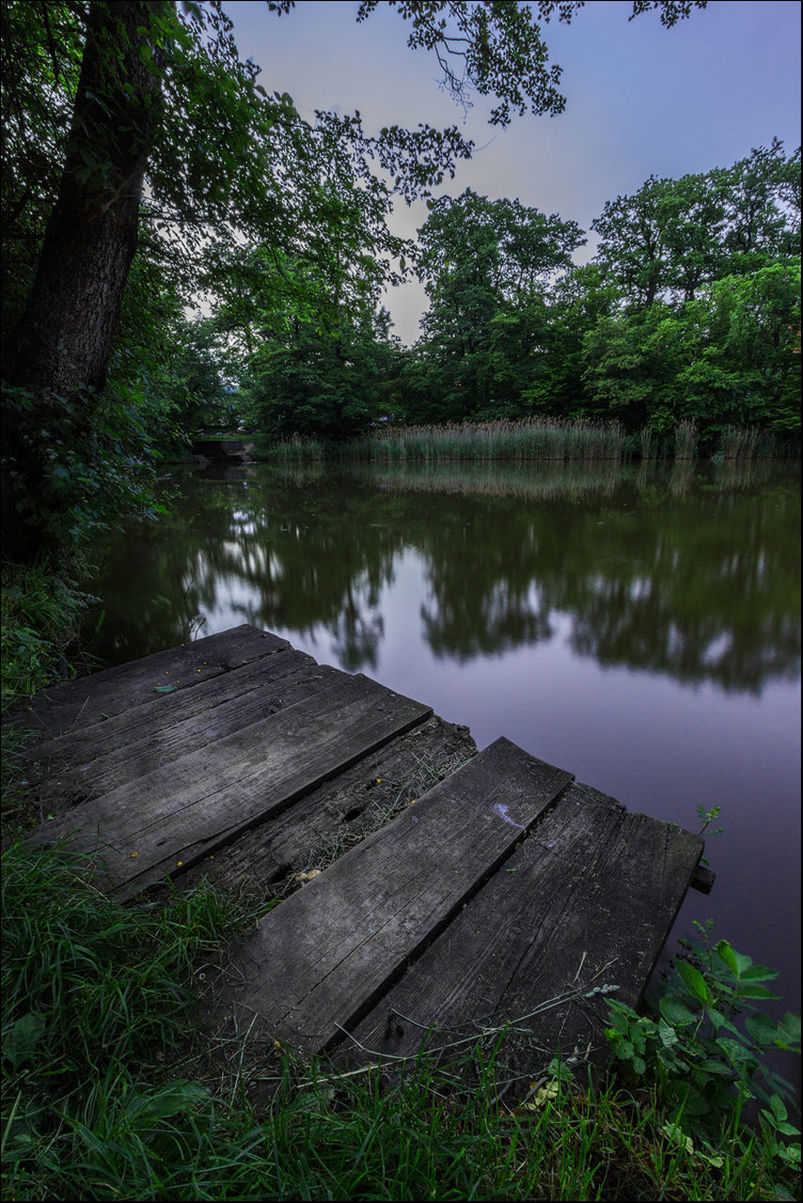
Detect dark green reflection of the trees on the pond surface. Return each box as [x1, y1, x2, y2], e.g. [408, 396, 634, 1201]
[87, 462, 801, 694]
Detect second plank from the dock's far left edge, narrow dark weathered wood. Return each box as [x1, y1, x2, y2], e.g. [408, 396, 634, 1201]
[32, 651, 341, 810]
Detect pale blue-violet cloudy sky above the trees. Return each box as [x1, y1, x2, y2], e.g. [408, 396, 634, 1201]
[223, 0, 801, 344]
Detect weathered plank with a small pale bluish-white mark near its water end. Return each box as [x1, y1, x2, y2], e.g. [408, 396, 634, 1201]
[220, 739, 572, 1051]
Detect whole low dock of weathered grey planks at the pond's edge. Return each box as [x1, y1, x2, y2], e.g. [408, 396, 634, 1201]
[18, 626, 703, 1074]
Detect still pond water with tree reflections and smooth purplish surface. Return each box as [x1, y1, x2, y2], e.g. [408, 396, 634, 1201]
[83, 463, 801, 1073]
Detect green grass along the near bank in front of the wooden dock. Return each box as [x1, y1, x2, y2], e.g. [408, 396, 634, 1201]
[0, 845, 796, 1201]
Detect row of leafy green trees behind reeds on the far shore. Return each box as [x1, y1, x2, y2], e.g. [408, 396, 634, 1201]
[235, 140, 801, 450]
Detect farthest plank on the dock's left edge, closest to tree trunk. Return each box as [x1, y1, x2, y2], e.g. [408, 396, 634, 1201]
[18, 623, 290, 739]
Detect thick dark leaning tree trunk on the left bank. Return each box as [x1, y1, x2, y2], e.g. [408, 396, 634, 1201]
[2, 0, 172, 558]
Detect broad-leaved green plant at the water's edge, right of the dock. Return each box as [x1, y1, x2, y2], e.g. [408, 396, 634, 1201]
[607, 923, 801, 1163]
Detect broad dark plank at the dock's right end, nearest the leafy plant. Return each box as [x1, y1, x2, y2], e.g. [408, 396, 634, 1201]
[339, 786, 703, 1077]
